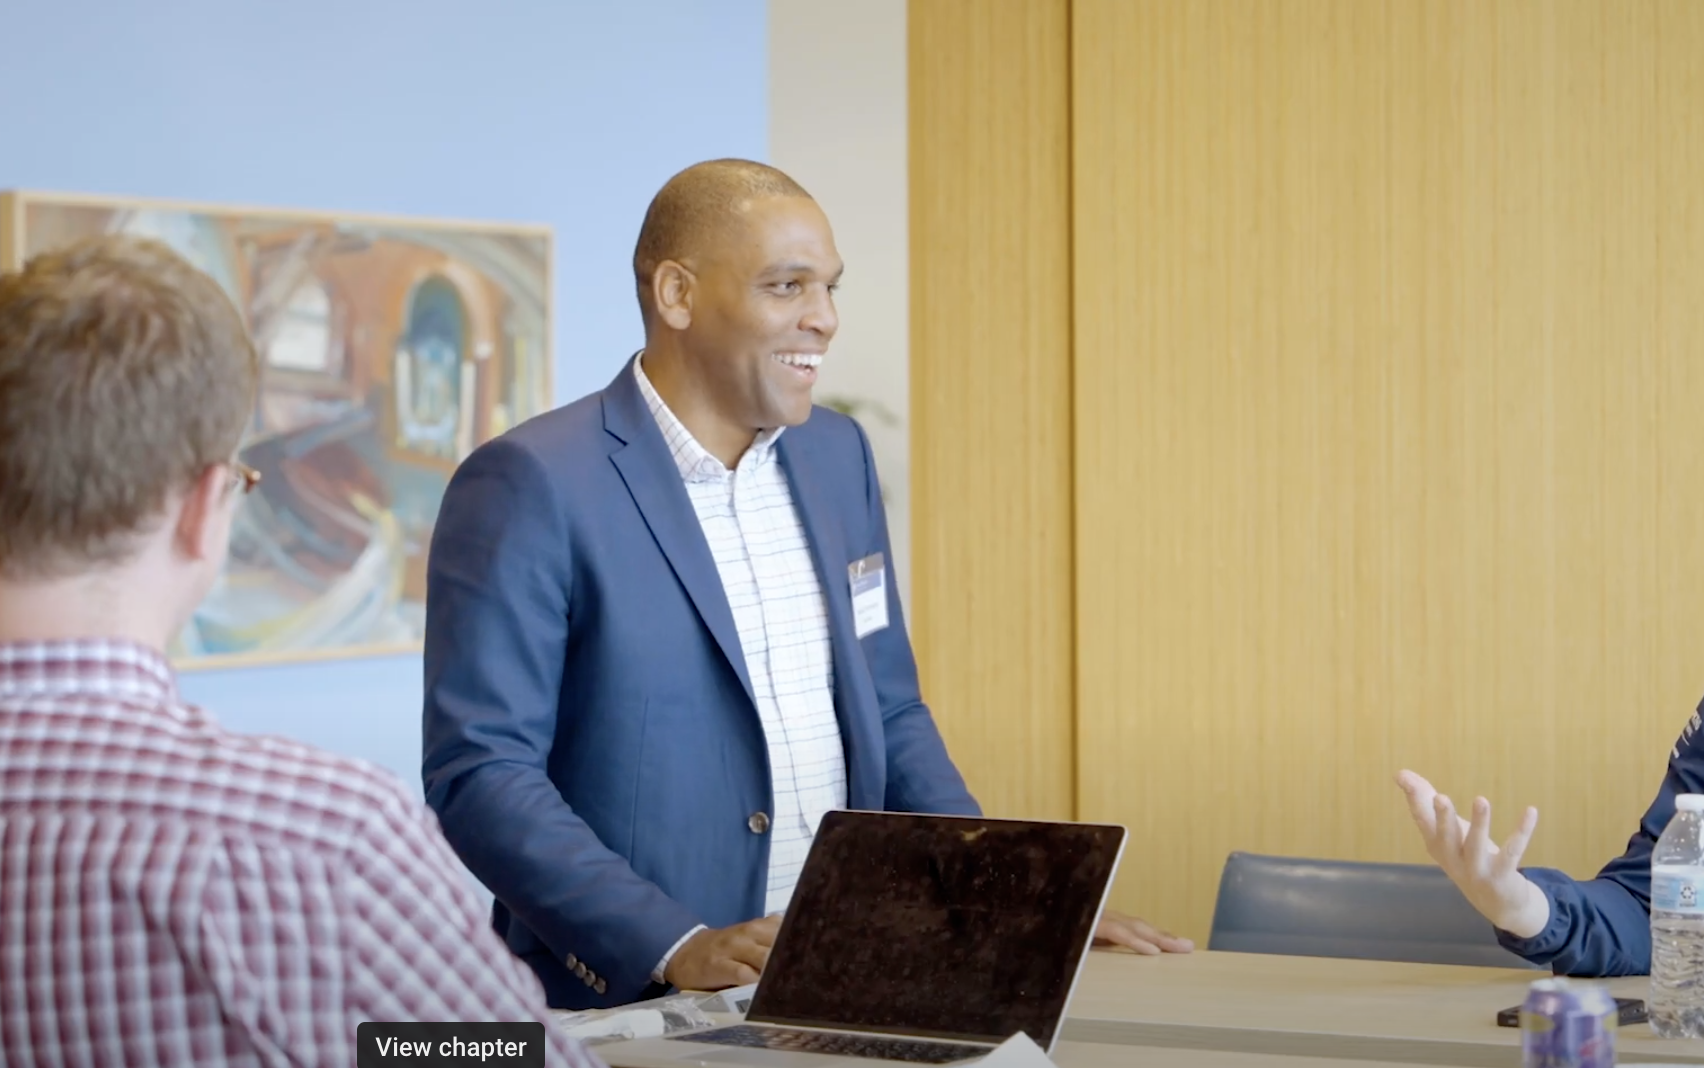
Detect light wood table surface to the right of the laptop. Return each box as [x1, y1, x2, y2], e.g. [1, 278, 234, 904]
[1060, 950, 1704, 1068]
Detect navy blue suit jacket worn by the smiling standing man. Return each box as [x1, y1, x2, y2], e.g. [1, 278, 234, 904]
[423, 361, 978, 1008]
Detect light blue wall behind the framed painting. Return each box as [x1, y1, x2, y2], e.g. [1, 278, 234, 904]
[0, 0, 769, 790]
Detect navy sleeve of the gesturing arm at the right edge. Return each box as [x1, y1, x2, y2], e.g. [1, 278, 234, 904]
[1498, 702, 1704, 976]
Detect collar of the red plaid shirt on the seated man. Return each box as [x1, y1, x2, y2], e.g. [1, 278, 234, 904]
[0, 639, 177, 705]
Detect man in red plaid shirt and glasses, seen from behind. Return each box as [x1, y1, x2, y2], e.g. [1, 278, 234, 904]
[0, 237, 596, 1068]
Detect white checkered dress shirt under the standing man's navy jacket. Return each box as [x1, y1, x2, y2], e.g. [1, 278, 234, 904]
[634, 359, 847, 913]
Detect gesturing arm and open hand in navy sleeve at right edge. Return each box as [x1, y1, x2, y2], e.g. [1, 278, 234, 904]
[1397, 703, 1704, 976]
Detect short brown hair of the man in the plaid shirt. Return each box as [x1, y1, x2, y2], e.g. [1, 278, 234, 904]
[0, 235, 259, 577]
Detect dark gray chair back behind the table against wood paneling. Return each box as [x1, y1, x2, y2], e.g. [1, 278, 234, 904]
[1206, 853, 1537, 968]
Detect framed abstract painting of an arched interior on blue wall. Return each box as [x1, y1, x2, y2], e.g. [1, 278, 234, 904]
[0, 192, 552, 668]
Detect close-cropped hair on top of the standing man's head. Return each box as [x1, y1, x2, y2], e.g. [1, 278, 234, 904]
[634, 160, 811, 324]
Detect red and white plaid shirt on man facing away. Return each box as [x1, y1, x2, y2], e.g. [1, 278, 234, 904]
[0, 642, 600, 1068]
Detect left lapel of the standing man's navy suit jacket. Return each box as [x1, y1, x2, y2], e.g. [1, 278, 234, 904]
[603, 361, 757, 707]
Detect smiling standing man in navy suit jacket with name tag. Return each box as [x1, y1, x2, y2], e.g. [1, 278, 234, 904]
[424, 160, 1188, 1007]
